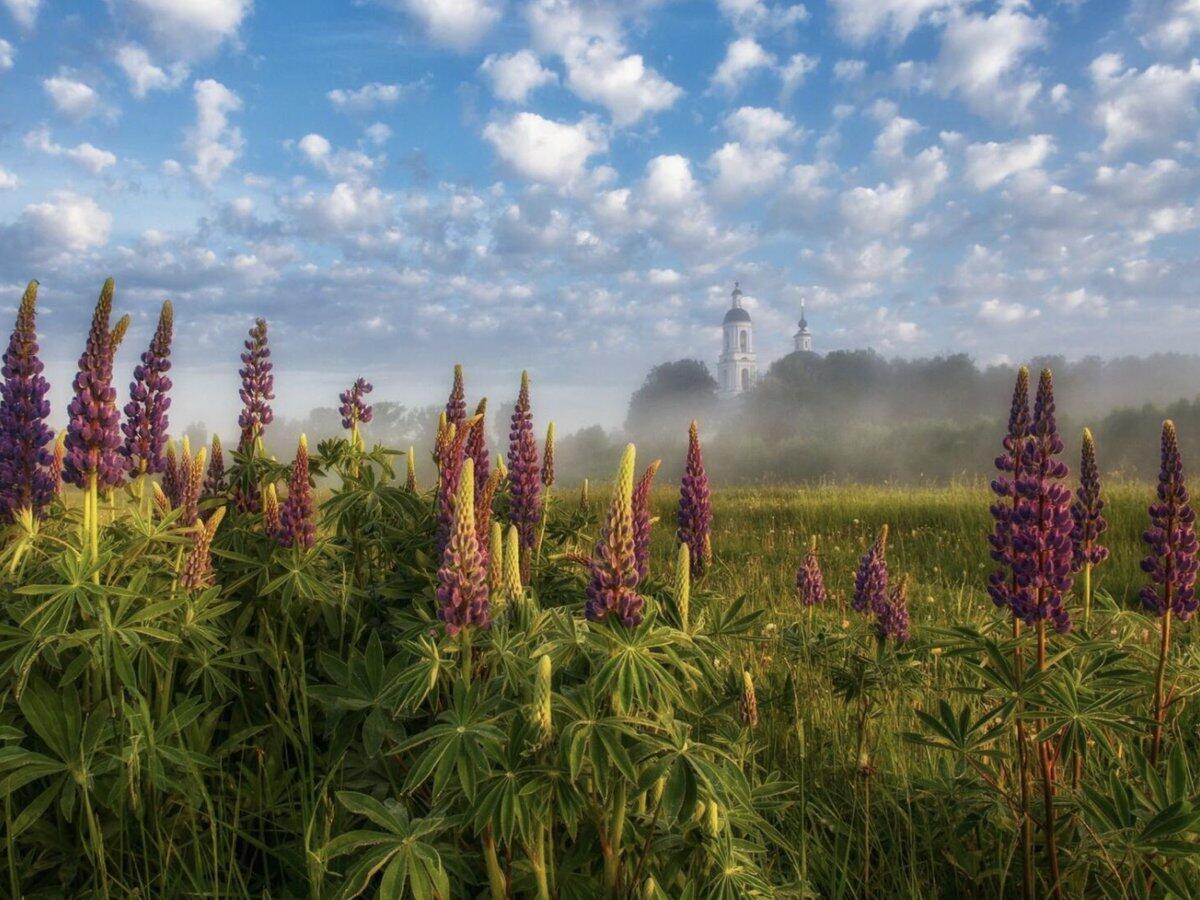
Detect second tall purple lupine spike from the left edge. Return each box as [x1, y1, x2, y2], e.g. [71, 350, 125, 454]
[62, 278, 125, 491]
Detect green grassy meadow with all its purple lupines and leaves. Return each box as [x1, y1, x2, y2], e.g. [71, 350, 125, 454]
[0, 282, 1200, 900]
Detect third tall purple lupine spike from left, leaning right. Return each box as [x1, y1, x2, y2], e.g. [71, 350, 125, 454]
[121, 300, 174, 475]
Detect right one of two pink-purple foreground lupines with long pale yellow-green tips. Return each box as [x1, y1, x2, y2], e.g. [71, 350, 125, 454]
[584, 444, 646, 628]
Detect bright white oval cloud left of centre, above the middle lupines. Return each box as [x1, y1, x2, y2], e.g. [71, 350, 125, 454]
[484, 113, 608, 190]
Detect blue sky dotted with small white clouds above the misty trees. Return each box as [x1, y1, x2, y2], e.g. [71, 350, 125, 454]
[0, 0, 1200, 430]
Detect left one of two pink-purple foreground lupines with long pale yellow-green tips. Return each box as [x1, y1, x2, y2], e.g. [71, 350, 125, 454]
[438, 460, 491, 637]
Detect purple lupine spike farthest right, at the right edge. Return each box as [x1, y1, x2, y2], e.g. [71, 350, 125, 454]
[1141, 420, 1198, 622]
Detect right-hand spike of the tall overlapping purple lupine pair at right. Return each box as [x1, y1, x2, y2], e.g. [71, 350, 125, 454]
[1012, 368, 1075, 632]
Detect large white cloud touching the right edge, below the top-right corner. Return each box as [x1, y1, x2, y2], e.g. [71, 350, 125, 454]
[1091, 53, 1200, 155]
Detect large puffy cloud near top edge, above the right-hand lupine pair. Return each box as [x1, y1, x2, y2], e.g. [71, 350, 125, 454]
[936, 5, 1046, 121]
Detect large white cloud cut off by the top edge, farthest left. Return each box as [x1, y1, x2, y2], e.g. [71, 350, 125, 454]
[118, 0, 251, 60]
